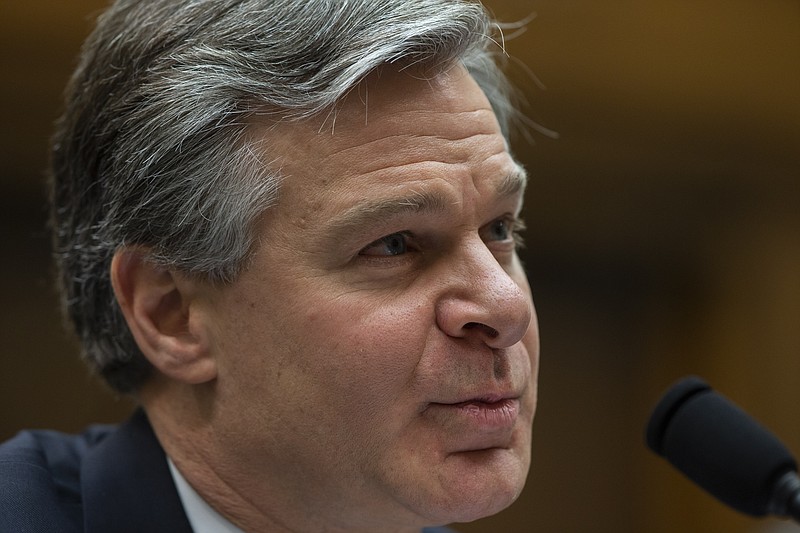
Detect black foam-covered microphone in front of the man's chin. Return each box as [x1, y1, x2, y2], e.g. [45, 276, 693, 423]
[646, 376, 800, 523]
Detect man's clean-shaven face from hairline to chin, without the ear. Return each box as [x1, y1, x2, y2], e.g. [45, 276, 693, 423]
[202, 64, 538, 530]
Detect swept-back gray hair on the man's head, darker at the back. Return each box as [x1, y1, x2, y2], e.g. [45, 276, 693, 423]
[51, 0, 514, 392]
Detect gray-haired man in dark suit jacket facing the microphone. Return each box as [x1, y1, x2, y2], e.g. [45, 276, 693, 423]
[0, 0, 538, 532]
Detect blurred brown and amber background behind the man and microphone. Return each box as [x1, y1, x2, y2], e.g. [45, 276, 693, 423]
[0, 0, 800, 533]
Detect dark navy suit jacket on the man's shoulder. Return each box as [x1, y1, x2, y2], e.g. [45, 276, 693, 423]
[0, 410, 456, 533]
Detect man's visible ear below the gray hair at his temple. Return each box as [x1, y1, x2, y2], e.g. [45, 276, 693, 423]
[111, 248, 217, 384]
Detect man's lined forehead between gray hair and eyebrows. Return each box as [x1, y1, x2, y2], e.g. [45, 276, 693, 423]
[253, 67, 524, 220]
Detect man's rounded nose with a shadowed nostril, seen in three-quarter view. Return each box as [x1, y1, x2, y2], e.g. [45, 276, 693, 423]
[436, 238, 533, 349]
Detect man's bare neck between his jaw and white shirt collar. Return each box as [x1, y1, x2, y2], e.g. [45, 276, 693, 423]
[139, 377, 420, 533]
